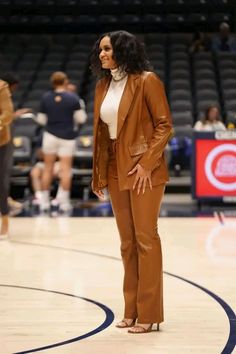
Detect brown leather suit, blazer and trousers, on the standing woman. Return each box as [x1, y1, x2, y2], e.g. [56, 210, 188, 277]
[93, 72, 172, 323]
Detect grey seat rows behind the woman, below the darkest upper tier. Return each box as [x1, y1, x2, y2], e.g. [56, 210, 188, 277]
[0, 33, 236, 120]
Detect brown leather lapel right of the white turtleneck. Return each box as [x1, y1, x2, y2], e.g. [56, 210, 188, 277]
[117, 74, 139, 138]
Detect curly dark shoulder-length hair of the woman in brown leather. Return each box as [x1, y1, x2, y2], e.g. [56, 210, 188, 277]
[90, 31, 152, 77]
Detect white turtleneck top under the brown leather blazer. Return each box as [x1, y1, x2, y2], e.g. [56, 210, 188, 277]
[100, 69, 127, 139]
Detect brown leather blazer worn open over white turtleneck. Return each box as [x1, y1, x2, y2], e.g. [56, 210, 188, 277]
[93, 72, 173, 190]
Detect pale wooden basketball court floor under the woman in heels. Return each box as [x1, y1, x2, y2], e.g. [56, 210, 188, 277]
[0, 217, 236, 354]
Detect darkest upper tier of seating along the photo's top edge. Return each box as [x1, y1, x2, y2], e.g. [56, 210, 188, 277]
[0, 0, 235, 33]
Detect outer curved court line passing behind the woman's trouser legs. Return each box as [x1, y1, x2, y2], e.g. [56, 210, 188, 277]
[9, 241, 236, 354]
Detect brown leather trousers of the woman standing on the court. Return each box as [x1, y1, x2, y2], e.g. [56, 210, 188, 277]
[108, 142, 165, 323]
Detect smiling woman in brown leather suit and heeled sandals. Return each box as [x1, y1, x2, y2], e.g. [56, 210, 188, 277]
[91, 31, 172, 333]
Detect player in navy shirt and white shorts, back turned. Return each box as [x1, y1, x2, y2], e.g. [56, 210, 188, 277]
[37, 71, 84, 212]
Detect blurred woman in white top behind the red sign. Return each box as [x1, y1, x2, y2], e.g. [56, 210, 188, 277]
[194, 105, 226, 132]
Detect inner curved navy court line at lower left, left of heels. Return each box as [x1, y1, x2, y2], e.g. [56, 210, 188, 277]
[0, 284, 114, 354]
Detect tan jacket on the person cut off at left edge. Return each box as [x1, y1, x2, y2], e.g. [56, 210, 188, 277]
[0, 80, 14, 146]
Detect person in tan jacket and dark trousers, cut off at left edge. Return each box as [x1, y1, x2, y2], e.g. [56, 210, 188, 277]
[0, 80, 14, 239]
